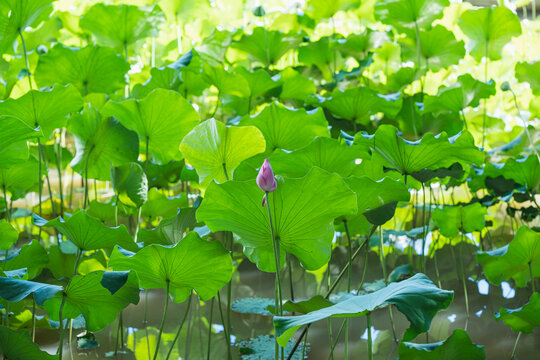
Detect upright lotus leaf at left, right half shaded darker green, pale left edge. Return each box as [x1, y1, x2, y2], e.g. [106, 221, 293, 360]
[68, 104, 139, 180]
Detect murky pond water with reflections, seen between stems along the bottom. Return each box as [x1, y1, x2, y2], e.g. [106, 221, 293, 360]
[33, 244, 540, 360]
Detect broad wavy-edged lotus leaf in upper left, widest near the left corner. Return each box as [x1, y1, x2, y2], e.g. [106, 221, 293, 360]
[35, 44, 129, 95]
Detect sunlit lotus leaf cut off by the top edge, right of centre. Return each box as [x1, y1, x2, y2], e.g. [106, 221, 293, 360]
[375, 0, 449, 37]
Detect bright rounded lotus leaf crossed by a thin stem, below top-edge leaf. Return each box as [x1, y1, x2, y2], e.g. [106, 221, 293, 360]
[402, 25, 465, 72]
